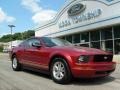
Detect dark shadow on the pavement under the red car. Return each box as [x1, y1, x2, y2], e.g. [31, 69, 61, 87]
[22, 69, 116, 86]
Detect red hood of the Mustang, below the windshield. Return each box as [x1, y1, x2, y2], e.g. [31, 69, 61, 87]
[54, 46, 109, 54]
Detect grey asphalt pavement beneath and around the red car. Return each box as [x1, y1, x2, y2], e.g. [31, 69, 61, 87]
[0, 54, 120, 90]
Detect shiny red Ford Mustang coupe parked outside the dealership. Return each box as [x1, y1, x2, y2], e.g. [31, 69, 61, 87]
[10, 37, 116, 84]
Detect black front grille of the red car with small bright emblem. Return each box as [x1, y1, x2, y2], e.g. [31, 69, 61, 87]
[94, 55, 113, 62]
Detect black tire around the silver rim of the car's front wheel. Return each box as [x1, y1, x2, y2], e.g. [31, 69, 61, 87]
[50, 58, 72, 84]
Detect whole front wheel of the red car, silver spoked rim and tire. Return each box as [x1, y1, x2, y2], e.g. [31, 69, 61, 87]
[51, 58, 71, 84]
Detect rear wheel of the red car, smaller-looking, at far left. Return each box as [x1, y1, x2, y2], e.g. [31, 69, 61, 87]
[12, 56, 21, 71]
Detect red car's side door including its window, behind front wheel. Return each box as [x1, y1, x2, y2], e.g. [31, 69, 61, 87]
[24, 39, 43, 68]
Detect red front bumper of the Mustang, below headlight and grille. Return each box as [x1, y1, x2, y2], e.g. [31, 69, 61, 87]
[72, 62, 116, 78]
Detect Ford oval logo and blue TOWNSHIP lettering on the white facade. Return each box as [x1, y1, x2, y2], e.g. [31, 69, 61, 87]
[59, 7, 102, 28]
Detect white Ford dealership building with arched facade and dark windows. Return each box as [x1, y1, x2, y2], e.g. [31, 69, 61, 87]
[35, 0, 120, 54]
